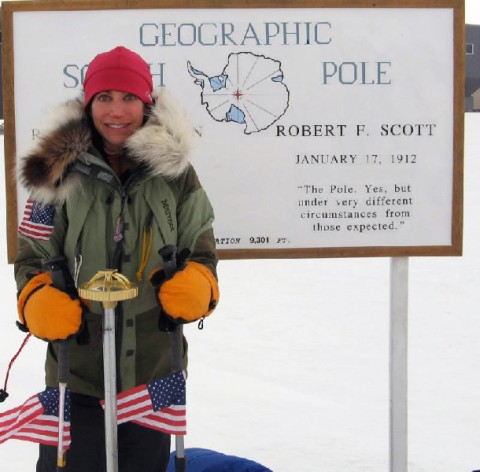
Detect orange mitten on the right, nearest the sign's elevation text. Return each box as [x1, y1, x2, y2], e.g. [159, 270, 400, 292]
[150, 261, 219, 323]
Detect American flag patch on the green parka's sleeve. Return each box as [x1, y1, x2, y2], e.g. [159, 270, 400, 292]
[18, 198, 55, 241]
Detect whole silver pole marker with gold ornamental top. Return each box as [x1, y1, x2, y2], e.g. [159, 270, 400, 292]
[78, 270, 138, 472]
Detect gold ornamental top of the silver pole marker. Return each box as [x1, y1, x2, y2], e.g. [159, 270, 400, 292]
[78, 269, 138, 308]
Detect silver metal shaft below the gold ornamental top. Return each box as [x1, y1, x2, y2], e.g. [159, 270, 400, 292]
[103, 304, 118, 472]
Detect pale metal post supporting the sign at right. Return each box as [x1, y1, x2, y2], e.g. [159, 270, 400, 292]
[390, 257, 408, 472]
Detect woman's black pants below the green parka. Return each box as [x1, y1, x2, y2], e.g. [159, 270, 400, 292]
[36, 394, 170, 472]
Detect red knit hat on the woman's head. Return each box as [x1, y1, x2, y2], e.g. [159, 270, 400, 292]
[83, 46, 153, 106]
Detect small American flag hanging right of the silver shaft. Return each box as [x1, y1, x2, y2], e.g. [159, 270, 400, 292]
[113, 372, 187, 435]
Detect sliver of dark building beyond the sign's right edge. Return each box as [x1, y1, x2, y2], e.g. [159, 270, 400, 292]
[465, 25, 480, 111]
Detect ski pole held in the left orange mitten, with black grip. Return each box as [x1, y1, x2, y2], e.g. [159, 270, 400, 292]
[45, 256, 78, 470]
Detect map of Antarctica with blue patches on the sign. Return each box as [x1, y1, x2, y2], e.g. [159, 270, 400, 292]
[187, 52, 290, 134]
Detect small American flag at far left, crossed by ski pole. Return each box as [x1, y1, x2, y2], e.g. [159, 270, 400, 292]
[0, 388, 71, 449]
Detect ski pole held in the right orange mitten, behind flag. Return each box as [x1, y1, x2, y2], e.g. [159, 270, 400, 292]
[158, 245, 187, 472]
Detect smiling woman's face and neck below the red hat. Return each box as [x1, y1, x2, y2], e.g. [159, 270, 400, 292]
[92, 90, 145, 153]
